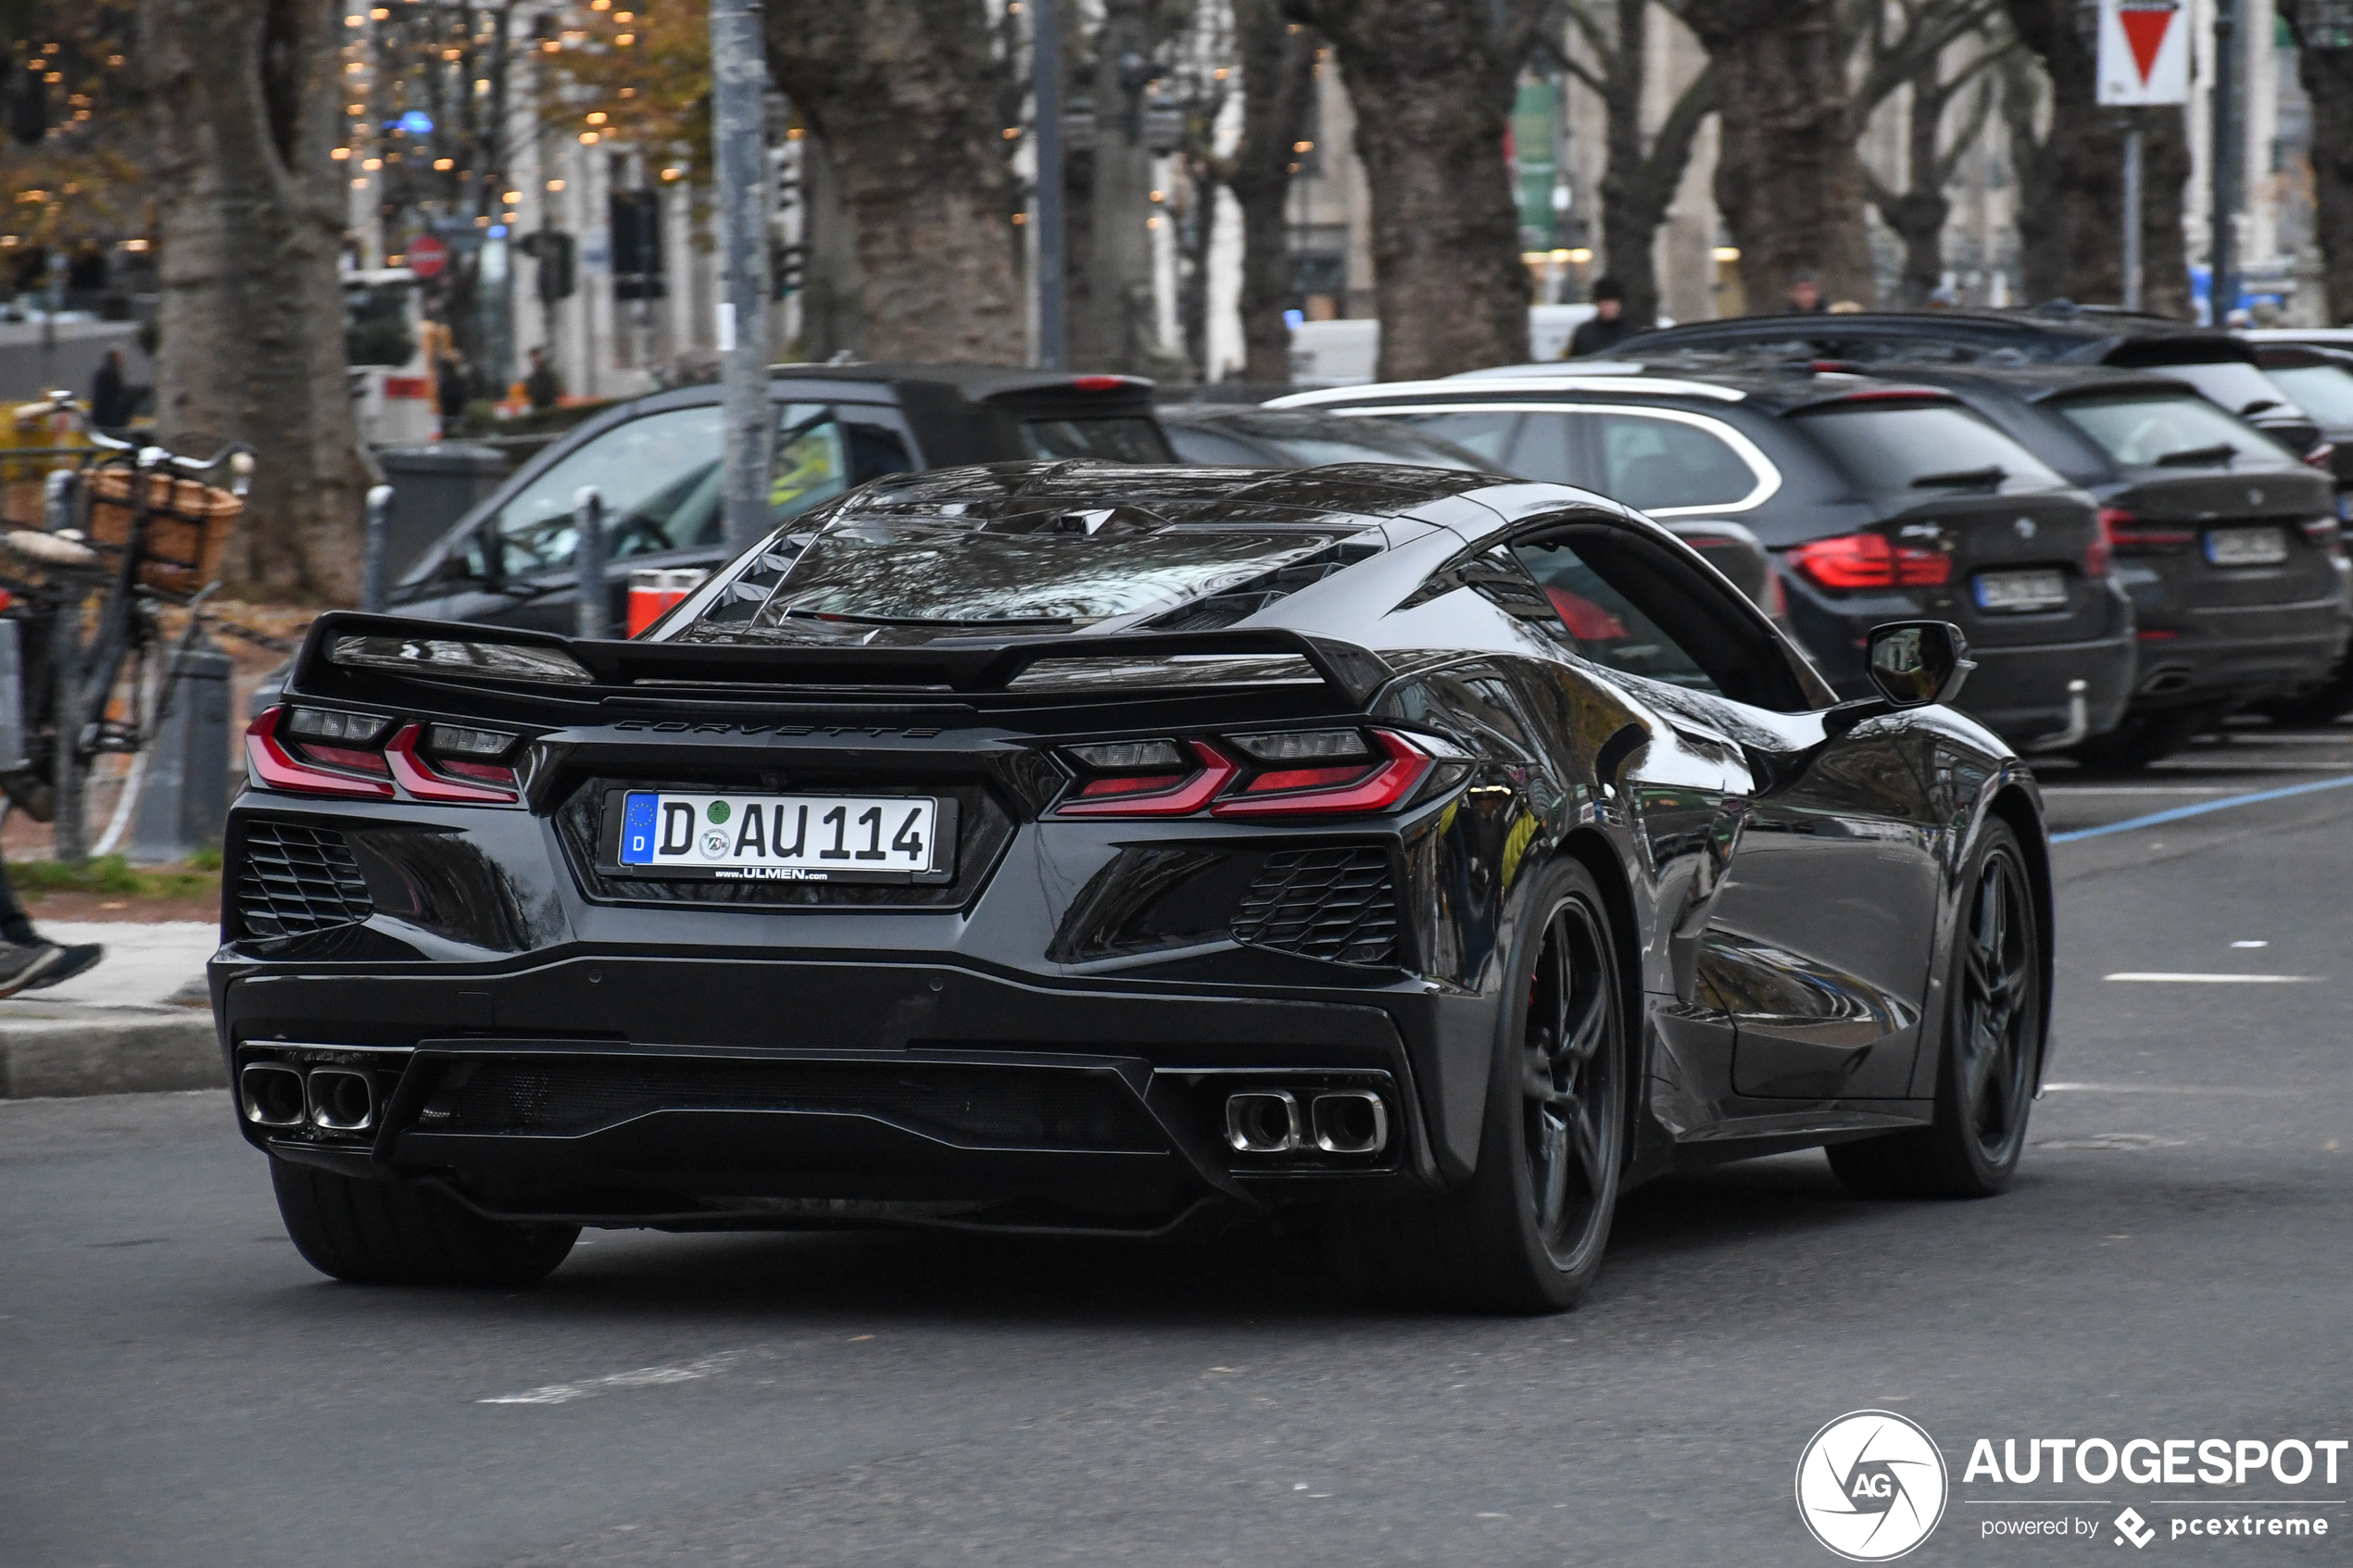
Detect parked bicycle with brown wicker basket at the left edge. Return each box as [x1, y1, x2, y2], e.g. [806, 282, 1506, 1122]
[0, 393, 254, 863]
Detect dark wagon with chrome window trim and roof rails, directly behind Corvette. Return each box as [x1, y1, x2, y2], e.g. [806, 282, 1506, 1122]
[1276, 362, 2134, 750]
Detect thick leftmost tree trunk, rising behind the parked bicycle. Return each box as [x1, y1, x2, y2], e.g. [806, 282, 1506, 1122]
[139, 0, 370, 602]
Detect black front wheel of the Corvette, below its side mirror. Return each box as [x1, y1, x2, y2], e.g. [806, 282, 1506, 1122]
[1826, 822, 2043, 1198]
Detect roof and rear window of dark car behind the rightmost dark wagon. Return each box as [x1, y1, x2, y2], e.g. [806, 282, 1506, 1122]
[1609, 301, 2330, 463]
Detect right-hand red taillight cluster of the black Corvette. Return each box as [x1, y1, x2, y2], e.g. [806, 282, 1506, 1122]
[1054, 729, 1459, 818]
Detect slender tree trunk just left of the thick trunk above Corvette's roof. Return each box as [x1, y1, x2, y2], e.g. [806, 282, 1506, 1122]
[1226, 0, 1322, 383]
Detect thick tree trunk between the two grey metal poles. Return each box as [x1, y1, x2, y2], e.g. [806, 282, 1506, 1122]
[765, 0, 1028, 364]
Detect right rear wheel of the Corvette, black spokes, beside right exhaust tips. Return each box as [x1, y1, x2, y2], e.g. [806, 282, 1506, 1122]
[1334, 860, 1630, 1311]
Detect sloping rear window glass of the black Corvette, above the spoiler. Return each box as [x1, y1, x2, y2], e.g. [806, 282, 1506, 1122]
[758, 524, 1332, 628]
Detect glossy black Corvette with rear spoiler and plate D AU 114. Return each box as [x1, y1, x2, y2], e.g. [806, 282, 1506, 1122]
[212, 463, 2049, 1310]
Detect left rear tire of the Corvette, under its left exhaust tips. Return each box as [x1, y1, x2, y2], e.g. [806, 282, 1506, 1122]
[271, 1157, 581, 1286]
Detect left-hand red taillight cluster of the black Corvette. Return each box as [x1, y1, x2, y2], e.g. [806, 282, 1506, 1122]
[245, 708, 522, 807]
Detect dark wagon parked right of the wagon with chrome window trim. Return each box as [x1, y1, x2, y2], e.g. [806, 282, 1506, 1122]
[1844, 364, 2346, 766]
